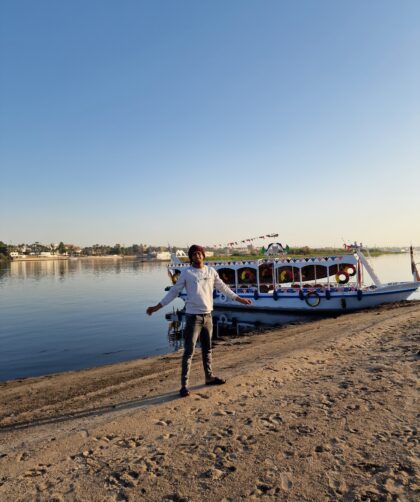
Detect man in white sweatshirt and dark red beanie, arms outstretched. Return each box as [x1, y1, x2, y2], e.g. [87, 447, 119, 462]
[146, 244, 252, 397]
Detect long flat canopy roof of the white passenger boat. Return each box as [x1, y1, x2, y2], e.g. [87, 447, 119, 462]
[169, 254, 358, 270]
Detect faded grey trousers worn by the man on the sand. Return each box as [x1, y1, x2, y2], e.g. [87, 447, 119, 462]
[181, 314, 213, 387]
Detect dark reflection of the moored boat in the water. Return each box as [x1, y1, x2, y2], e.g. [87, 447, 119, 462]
[165, 308, 320, 350]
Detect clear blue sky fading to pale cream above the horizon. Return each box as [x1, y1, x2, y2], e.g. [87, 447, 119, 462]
[0, 0, 420, 246]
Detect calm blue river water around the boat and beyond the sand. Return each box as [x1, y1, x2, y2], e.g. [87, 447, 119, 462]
[0, 254, 420, 380]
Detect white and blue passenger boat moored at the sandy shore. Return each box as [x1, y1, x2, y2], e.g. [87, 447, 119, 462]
[167, 244, 420, 313]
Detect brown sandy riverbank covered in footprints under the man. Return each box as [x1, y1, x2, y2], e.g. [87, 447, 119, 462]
[0, 302, 420, 502]
